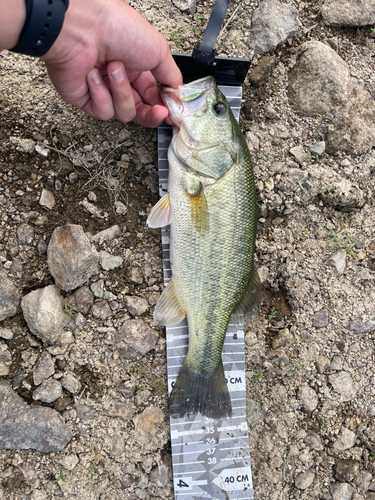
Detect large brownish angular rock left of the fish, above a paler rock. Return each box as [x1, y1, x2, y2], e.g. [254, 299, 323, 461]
[48, 224, 99, 291]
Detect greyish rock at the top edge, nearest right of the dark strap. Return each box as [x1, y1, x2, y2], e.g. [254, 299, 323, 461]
[249, 0, 298, 54]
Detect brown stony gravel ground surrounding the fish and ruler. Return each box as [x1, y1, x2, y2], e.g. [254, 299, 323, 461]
[0, 0, 375, 500]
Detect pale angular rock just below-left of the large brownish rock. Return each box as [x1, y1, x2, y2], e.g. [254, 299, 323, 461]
[21, 285, 69, 344]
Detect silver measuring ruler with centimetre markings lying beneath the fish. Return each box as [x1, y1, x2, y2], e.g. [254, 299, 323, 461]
[158, 86, 254, 500]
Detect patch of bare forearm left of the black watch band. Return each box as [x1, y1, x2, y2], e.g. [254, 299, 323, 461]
[0, 0, 26, 49]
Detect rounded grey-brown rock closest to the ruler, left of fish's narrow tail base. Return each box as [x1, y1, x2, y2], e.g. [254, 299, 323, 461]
[116, 319, 159, 361]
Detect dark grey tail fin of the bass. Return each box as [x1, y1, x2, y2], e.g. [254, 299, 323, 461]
[168, 360, 232, 419]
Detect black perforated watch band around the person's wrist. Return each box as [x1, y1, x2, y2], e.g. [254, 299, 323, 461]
[10, 0, 69, 57]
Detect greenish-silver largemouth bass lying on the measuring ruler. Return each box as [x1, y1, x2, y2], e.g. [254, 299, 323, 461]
[147, 76, 261, 419]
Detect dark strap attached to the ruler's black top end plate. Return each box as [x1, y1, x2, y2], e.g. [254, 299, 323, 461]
[193, 0, 230, 64]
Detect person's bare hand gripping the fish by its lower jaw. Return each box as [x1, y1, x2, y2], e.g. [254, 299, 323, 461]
[42, 0, 182, 127]
